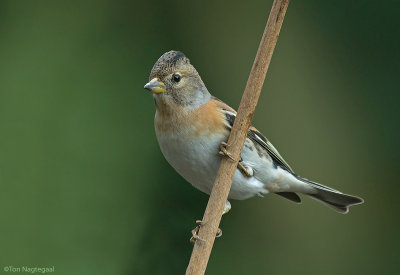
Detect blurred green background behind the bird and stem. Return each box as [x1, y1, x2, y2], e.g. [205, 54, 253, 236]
[0, 0, 400, 275]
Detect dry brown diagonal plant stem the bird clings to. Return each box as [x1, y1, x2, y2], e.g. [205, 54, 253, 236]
[186, 0, 289, 275]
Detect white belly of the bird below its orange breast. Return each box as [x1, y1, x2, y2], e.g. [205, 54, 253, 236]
[156, 131, 268, 200]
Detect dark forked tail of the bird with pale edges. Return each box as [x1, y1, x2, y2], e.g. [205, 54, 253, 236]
[298, 177, 364, 214]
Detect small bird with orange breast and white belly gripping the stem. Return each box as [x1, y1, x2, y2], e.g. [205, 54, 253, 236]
[144, 51, 363, 217]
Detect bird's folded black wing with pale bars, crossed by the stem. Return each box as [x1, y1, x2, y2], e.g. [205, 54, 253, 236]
[213, 98, 294, 174]
